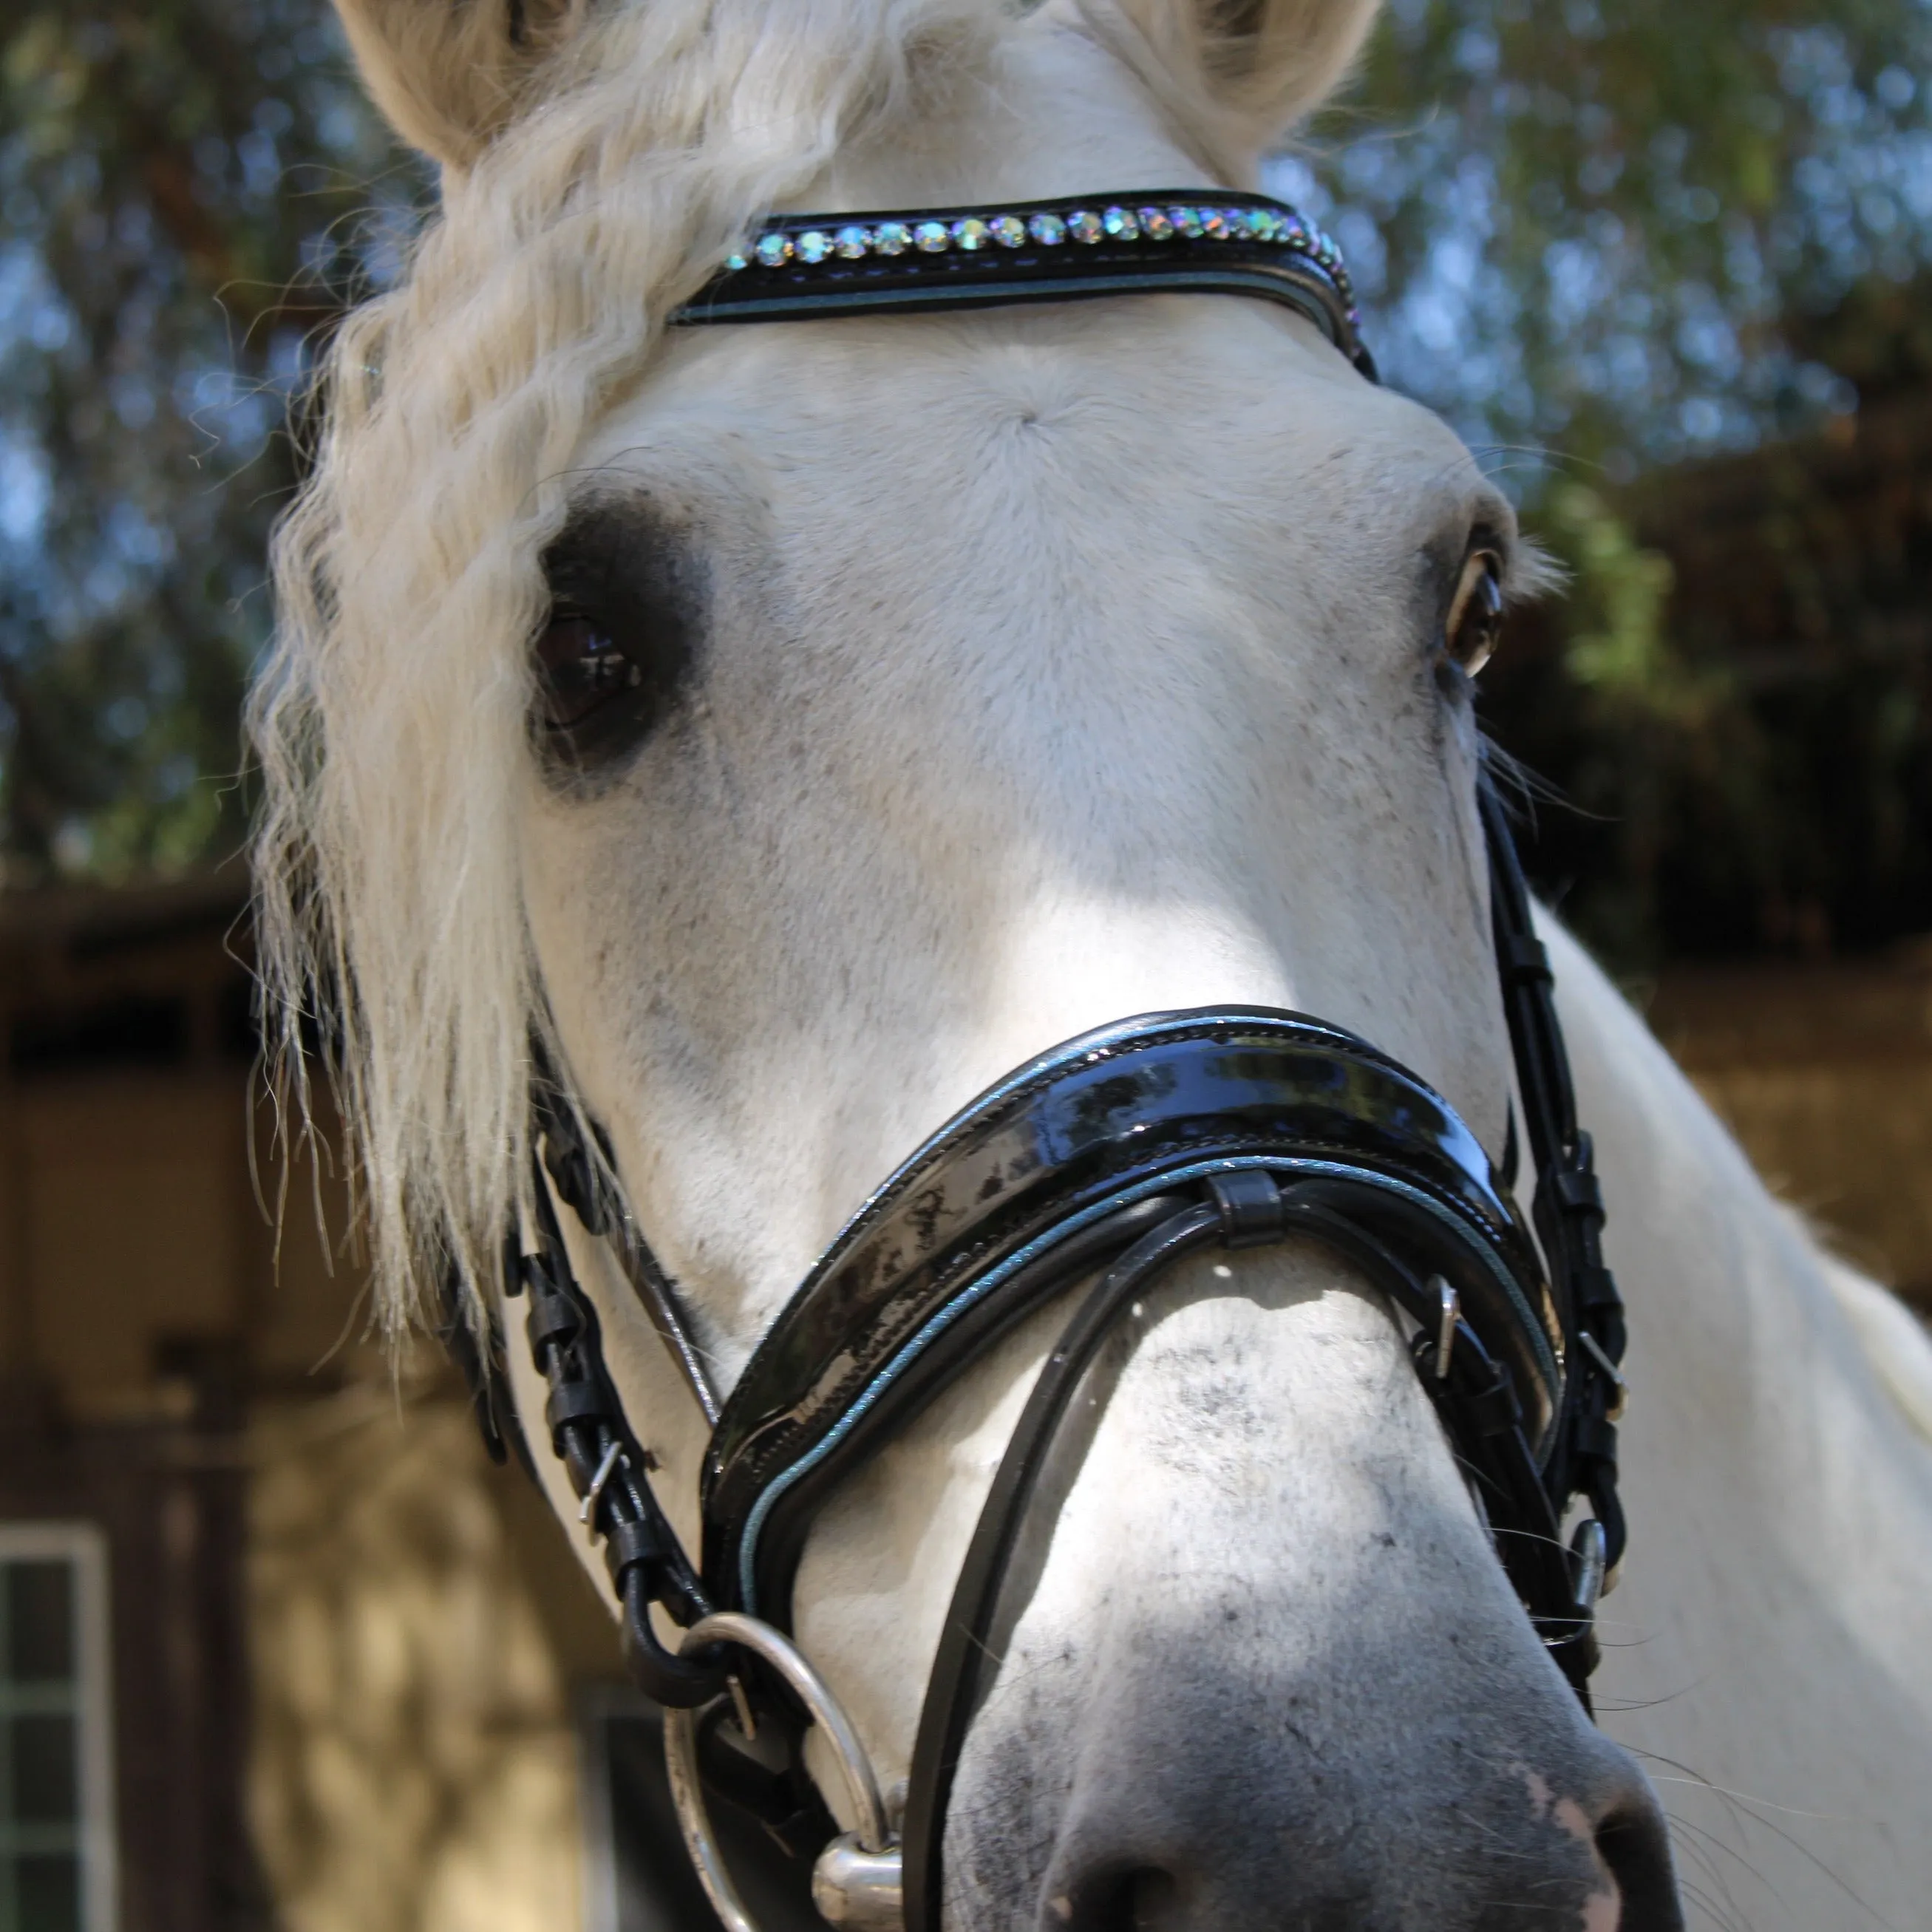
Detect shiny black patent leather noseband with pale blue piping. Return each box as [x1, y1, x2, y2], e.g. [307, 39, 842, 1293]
[705, 1009, 1563, 1623]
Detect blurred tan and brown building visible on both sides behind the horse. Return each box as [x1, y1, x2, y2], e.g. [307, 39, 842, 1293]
[0, 877, 1932, 1932]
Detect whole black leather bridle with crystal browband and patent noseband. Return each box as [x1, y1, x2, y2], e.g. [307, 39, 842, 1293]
[444, 191, 1625, 1932]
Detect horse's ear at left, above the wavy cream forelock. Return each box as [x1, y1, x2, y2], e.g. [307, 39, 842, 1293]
[336, 0, 588, 168]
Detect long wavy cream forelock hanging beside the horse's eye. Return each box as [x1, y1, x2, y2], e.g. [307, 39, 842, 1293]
[249, 0, 1010, 1333]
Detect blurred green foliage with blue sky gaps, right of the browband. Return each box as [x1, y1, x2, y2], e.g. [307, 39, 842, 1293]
[1285, 0, 1932, 471]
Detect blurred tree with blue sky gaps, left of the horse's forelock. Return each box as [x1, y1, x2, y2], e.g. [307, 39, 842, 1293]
[0, 0, 407, 881]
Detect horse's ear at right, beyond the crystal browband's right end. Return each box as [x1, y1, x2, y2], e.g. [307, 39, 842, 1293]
[1082, 0, 1381, 153]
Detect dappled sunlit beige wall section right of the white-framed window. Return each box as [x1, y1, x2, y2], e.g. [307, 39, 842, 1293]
[248, 1387, 618, 1932]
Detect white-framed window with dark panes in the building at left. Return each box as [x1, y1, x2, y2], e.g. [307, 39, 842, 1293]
[0, 1523, 114, 1932]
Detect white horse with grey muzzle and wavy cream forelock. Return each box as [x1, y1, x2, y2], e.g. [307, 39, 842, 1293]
[253, 0, 1932, 1932]
